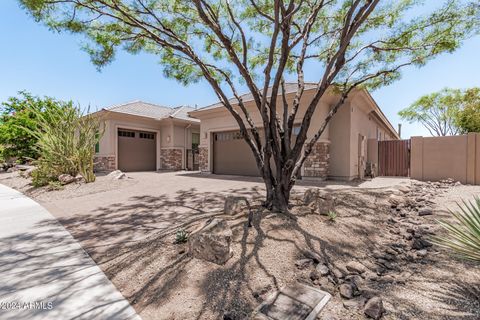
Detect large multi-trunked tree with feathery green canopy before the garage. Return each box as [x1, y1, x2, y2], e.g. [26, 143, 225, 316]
[20, 0, 479, 213]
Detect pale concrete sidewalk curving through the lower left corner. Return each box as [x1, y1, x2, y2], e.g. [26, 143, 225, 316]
[0, 184, 140, 320]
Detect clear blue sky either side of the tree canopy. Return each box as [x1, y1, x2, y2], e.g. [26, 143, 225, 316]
[0, 0, 480, 137]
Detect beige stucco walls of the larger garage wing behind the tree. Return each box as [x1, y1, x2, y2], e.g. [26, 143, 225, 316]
[194, 91, 393, 180]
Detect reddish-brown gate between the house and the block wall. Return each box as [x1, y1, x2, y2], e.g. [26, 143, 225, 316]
[378, 140, 410, 177]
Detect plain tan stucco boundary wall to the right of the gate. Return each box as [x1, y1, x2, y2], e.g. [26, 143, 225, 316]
[411, 133, 480, 184]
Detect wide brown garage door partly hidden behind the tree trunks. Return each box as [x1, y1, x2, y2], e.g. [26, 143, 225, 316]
[213, 131, 260, 176]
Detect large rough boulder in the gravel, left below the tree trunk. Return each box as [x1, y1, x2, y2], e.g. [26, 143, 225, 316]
[188, 218, 233, 264]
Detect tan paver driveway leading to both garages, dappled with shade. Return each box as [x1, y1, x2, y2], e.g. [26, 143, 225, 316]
[32, 172, 408, 250]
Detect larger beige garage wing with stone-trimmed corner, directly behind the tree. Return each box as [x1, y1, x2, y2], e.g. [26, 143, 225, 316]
[189, 83, 399, 180]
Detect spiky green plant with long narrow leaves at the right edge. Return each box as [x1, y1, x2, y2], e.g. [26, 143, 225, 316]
[433, 198, 480, 262]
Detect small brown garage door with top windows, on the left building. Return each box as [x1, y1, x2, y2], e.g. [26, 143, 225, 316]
[118, 129, 157, 172]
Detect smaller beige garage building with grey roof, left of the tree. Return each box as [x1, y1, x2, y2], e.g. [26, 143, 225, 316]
[94, 101, 200, 171]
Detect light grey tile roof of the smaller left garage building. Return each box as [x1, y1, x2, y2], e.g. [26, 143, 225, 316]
[104, 101, 199, 122]
